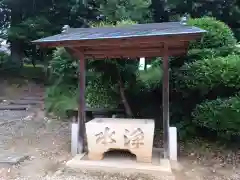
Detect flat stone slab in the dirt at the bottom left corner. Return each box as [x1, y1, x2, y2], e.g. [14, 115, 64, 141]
[0, 153, 29, 165]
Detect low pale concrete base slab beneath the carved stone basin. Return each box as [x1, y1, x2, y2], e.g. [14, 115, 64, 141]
[66, 150, 172, 175]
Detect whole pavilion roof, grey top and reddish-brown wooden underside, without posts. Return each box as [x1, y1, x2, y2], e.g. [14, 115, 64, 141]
[33, 22, 206, 59]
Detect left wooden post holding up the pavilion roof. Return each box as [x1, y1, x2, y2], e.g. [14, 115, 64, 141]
[78, 53, 86, 153]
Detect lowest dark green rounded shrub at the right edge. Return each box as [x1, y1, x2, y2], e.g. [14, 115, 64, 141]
[192, 95, 240, 138]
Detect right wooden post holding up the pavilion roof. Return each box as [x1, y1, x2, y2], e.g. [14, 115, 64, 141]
[162, 43, 169, 158]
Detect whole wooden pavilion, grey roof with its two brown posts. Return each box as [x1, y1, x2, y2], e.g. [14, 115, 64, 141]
[33, 22, 205, 158]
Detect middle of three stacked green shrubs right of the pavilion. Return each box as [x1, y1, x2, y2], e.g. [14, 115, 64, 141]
[176, 55, 240, 94]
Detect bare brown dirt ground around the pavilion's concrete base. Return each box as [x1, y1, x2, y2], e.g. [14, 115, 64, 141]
[0, 84, 240, 180]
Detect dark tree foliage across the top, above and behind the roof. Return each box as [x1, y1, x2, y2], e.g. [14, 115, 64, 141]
[0, 0, 240, 67]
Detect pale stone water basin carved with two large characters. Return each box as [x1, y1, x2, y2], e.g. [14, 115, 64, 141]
[86, 118, 154, 163]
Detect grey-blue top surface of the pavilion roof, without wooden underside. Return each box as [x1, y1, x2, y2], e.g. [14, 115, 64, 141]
[33, 22, 206, 43]
